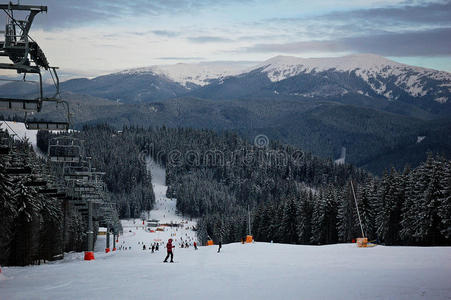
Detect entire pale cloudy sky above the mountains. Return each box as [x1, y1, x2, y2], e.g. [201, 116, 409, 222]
[0, 0, 451, 75]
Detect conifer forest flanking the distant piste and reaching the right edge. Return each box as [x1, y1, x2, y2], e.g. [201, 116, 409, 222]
[33, 125, 451, 245]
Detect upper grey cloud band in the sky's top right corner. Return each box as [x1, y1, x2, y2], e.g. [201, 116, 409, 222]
[260, 0, 451, 39]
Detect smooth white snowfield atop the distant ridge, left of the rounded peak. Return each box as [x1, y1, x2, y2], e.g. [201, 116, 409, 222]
[119, 62, 248, 88]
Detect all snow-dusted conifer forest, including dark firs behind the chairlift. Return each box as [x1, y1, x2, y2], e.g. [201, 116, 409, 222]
[0, 125, 451, 265]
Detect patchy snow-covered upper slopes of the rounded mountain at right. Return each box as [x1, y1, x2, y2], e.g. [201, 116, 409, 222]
[254, 54, 451, 103]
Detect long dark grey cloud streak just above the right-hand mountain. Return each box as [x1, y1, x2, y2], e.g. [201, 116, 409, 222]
[243, 28, 451, 56]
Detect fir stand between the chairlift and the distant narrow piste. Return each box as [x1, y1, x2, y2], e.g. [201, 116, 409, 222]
[37, 125, 155, 218]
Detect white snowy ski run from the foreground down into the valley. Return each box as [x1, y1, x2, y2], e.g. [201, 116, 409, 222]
[0, 164, 451, 300]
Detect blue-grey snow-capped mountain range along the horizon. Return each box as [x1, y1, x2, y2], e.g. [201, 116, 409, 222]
[63, 54, 451, 119]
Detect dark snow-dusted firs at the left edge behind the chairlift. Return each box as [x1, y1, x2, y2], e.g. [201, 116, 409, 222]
[0, 130, 87, 265]
